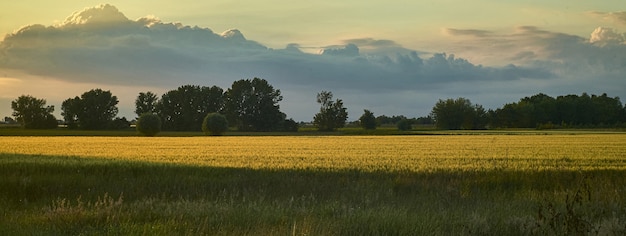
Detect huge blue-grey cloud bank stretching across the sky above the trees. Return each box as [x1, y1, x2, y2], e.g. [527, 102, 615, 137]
[0, 5, 626, 120]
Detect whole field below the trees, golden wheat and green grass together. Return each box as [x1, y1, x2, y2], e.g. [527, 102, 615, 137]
[0, 132, 626, 235]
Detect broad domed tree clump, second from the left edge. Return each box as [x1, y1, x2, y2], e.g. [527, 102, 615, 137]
[61, 89, 118, 130]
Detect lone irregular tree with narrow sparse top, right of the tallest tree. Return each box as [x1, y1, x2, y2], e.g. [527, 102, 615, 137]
[313, 91, 348, 131]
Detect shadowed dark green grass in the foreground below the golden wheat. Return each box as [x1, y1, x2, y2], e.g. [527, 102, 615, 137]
[0, 154, 626, 235]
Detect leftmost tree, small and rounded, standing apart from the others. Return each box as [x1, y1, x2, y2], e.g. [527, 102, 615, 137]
[11, 95, 57, 129]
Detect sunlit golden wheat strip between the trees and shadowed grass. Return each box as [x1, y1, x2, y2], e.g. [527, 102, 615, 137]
[0, 134, 626, 171]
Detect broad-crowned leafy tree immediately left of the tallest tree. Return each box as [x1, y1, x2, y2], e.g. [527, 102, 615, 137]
[157, 85, 224, 131]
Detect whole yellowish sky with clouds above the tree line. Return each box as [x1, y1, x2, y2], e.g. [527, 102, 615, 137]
[0, 0, 626, 121]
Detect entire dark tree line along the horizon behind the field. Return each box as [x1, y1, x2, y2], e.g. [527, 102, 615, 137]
[5, 78, 626, 133]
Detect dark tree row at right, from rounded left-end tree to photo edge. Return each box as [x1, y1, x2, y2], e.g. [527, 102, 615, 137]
[431, 93, 626, 129]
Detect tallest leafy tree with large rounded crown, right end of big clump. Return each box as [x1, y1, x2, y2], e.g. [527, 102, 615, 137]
[225, 78, 285, 131]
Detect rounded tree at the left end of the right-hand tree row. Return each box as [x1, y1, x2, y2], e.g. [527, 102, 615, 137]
[431, 98, 487, 129]
